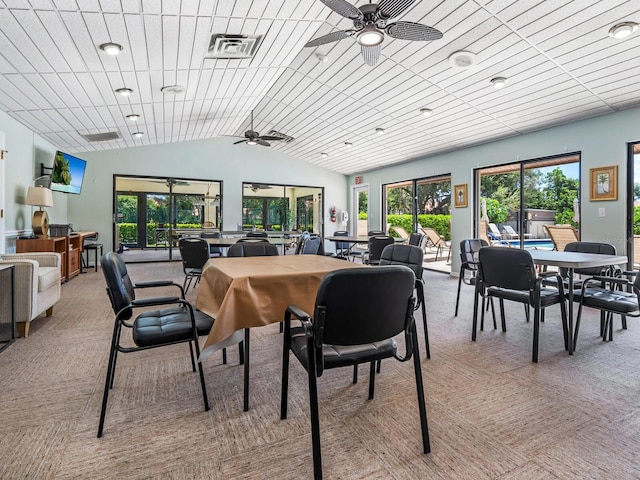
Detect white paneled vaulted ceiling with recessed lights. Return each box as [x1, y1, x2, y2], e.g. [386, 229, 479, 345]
[0, 0, 640, 174]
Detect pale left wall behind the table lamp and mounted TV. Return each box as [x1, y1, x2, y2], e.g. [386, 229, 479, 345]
[0, 111, 67, 251]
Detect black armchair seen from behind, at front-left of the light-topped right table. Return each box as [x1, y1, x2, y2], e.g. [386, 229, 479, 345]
[471, 247, 569, 363]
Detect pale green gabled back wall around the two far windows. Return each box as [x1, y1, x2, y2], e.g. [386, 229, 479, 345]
[68, 138, 347, 248]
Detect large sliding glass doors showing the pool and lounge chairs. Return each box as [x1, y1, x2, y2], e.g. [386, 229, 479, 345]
[475, 154, 580, 245]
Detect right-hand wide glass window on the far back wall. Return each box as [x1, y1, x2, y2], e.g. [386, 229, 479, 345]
[238, 182, 323, 234]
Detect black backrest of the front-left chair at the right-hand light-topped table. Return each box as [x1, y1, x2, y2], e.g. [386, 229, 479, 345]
[478, 247, 536, 291]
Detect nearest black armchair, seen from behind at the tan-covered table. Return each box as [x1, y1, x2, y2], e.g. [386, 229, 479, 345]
[280, 265, 431, 480]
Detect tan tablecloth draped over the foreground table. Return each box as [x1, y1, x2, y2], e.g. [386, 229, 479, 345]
[196, 255, 366, 358]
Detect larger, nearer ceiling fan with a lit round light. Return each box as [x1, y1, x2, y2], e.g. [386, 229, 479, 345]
[305, 0, 442, 66]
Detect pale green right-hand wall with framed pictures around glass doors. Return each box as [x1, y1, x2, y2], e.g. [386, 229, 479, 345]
[349, 108, 640, 272]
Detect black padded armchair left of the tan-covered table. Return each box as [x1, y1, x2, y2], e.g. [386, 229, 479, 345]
[98, 252, 214, 438]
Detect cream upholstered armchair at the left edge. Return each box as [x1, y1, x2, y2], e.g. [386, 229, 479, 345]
[0, 252, 61, 337]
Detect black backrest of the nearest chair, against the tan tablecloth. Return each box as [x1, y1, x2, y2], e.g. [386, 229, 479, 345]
[313, 265, 415, 347]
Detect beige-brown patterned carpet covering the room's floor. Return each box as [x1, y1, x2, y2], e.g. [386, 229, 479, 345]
[0, 262, 640, 480]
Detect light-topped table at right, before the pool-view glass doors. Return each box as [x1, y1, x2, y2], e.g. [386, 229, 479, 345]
[528, 249, 629, 355]
